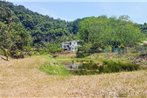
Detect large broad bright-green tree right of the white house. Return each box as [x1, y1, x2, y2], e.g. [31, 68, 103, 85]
[78, 16, 145, 57]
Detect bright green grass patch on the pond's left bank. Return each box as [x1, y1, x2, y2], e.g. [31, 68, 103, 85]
[40, 63, 70, 76]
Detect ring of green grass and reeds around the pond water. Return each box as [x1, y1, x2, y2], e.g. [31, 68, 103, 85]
[39, 54, 142, 76]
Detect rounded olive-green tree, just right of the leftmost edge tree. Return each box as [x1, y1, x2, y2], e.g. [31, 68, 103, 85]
[10, 23, 32, 58]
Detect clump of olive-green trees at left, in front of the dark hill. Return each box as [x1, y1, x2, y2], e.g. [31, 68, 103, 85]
[0, 5, 31, 60]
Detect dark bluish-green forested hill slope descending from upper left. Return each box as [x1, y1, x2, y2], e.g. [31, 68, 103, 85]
[0, 1, 76, 43]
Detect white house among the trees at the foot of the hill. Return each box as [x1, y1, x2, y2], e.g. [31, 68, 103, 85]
[61, 40, 79, 51]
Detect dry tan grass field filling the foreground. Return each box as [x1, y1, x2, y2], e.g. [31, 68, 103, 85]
[0, 56, 147, 98]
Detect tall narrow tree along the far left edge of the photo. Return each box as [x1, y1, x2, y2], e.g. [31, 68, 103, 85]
[0, 7, 12, 61]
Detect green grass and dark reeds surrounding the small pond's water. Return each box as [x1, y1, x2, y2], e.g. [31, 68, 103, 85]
[40, 53, 140, 76]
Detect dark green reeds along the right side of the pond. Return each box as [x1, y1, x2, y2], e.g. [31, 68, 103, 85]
[72, 60, 139, 75]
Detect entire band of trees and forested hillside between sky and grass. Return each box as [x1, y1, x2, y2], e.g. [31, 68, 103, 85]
[0, 1, 147, 57]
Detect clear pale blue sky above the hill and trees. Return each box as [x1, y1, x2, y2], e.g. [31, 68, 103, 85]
[7, 0, 147, 23]
